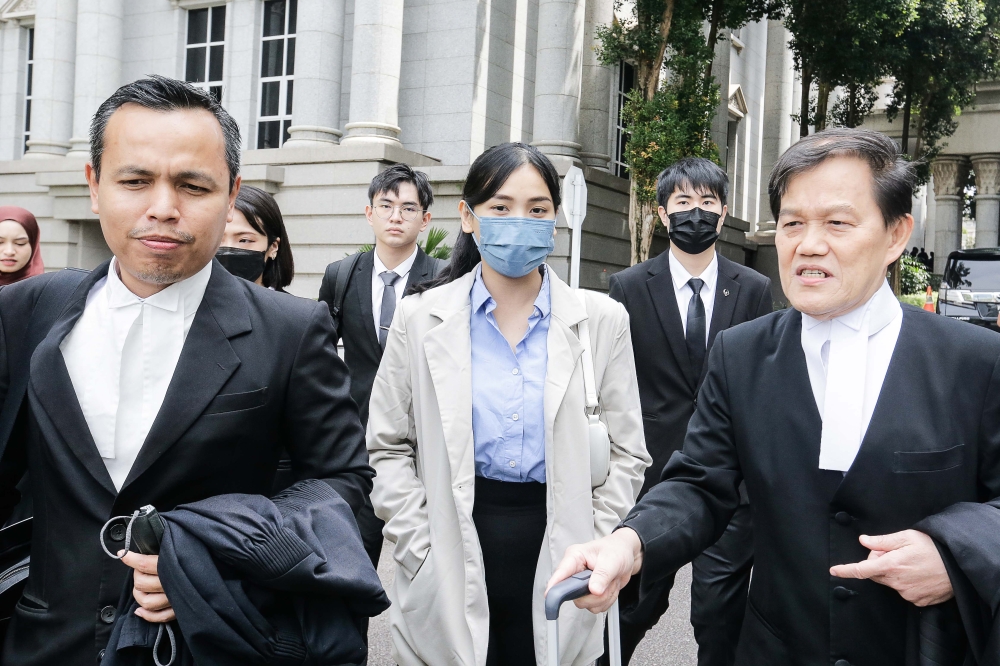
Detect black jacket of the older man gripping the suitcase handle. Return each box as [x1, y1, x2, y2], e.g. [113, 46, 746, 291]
[624, 305, 1000, 666]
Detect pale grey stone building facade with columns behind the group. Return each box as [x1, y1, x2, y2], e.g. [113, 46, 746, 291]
[0, 0, 798, 297]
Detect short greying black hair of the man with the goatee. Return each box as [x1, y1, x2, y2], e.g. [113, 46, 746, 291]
[90, 74, 240, 192]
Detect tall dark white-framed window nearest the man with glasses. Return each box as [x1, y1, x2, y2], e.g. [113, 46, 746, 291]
[257, 0, 298, 148]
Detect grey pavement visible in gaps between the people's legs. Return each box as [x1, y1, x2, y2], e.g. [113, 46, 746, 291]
[368, 542, 698, 666]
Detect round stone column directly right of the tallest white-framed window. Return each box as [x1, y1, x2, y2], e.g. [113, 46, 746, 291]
[285, 0, 344, 148]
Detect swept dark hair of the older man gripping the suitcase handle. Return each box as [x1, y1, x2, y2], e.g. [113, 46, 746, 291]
[767, 127, 917, 228]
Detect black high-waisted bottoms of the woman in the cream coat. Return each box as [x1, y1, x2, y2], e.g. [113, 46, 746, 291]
[472, 476, 546, 666]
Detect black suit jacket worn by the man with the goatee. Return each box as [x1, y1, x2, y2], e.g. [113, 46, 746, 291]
[0, 261, 374, 666]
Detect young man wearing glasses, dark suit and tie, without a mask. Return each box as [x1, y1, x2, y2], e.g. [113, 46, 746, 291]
[319, 164, 446, 567]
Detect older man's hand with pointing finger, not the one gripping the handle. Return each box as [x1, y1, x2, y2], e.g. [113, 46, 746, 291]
[830, 530, 955, 606]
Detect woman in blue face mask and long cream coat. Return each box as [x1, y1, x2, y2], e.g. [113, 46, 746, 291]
[368, 143, 650, 666]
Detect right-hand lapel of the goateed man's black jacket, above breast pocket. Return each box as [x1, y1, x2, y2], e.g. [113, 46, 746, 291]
[122, 260, 250, 490]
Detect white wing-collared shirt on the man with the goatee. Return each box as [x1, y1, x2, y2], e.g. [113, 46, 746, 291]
[60, 259, 212, 490]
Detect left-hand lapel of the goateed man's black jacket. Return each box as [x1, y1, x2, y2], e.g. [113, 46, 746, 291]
[30, 261, 117, 495]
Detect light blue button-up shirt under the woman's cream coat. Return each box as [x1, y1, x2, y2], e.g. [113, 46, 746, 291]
[470, 266, 552, 483]
